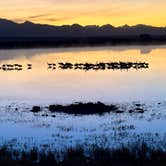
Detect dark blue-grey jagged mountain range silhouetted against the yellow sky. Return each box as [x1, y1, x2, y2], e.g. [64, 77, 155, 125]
[0, 19, 166, 37]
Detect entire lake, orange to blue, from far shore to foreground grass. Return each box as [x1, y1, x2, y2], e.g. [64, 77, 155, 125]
[0, 45, 166, 151]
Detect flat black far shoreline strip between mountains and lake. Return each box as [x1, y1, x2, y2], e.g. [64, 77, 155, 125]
[0, 36, 166, 49]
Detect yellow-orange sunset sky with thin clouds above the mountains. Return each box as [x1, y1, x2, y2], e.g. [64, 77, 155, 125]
[0, 0, 166, 26]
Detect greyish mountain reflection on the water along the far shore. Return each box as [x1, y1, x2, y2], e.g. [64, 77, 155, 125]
[0, 45, 166, 61]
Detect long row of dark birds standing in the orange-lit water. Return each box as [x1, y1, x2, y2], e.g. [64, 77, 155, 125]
[0, 62, 149, 71]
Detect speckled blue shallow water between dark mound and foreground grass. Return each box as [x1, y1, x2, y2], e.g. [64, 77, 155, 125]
[0, 102, 166, 150]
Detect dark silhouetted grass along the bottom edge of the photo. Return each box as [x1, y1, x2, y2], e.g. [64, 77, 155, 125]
[0, 143, 166, 166]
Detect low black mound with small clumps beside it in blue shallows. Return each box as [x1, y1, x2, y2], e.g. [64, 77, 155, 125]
[31, 101, 146, 115]
